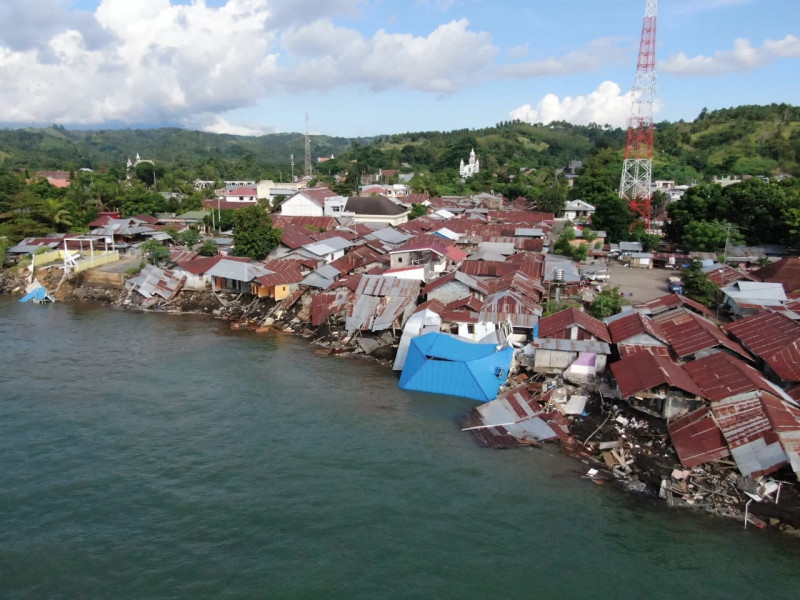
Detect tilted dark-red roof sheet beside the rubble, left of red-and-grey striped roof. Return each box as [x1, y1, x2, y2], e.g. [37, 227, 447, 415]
[667, 406, 730, 469]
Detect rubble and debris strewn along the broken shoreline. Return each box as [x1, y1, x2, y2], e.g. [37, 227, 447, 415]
[6, 271, 800, 535]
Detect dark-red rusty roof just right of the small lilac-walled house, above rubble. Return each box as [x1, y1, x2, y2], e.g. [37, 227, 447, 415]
[611, 352, 703, 398]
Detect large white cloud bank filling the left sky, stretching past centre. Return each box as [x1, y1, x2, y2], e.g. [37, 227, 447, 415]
[0, 0, 624, 131]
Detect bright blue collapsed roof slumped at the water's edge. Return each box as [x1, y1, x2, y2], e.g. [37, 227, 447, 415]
[400, 332, 514, 402]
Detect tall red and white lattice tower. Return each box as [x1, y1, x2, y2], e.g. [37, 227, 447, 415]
[619, 0, 658, 227]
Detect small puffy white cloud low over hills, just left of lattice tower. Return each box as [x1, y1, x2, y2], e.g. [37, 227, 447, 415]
[510, 81, 660, 127]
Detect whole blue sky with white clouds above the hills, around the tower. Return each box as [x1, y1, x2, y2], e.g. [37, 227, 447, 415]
[0, 0, 800, 137]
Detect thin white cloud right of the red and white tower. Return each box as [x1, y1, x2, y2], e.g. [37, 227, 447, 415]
[656, 35, 800, 77]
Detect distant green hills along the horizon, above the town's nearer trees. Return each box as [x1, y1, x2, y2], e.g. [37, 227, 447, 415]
[0, 104, 800, 182]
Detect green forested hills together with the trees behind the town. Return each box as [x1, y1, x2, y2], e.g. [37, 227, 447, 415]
[0, 104, 800, 249]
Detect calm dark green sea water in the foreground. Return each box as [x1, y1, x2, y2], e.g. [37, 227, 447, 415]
[0, 298, 800, 599]
